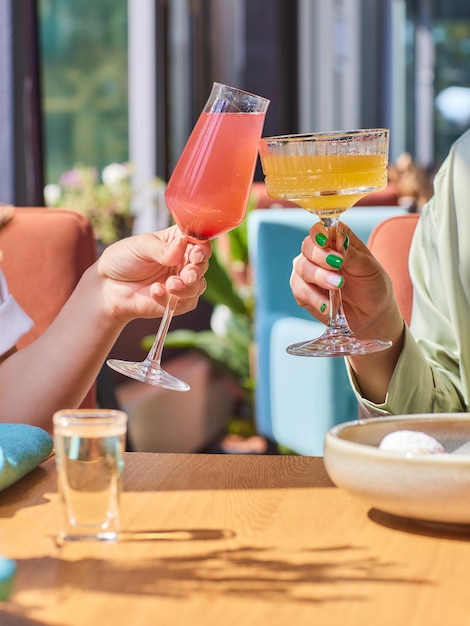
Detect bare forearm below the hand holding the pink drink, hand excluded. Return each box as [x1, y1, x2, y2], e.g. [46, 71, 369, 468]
[0, 268, 122, 431]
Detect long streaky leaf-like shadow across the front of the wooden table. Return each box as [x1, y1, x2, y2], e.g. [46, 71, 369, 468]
[12, 530, 432, 604]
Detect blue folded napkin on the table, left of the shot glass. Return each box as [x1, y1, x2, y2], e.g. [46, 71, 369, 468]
[0, 424, 53, 490]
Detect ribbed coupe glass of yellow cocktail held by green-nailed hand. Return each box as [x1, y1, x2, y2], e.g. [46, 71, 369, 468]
[260, 128, 392, 356]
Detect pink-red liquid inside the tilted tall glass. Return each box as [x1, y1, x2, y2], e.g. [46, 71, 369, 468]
[165, 112, 265, 241]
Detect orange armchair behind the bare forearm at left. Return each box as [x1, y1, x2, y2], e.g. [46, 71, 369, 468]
[0, 207, 96, 407]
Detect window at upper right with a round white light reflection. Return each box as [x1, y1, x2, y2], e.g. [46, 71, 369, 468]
[406, 0, 470, 168]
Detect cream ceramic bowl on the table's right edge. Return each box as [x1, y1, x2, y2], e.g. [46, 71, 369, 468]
[324, 413, 470, 524]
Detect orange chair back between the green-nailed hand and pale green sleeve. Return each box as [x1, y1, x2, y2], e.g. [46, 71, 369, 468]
[367, 213, 419, 325]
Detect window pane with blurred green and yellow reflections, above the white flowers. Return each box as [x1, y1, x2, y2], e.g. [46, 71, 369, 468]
[38, 0, 129, 183]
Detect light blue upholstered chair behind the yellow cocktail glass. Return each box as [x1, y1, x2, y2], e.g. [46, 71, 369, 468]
[248, 207, 406, 455]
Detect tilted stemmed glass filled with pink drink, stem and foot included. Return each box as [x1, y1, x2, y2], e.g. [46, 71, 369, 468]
[107, 83, 269, 391]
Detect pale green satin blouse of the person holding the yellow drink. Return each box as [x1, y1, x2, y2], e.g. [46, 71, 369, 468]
[348, 131, 470, 416]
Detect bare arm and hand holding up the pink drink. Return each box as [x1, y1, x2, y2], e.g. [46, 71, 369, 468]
[0, 227, 210, 430]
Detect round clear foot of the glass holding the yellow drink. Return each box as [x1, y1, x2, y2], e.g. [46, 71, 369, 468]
[286, 329, 392, 357]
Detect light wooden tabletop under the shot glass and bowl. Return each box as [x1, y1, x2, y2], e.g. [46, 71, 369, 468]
[0, 453, 470, 626]
